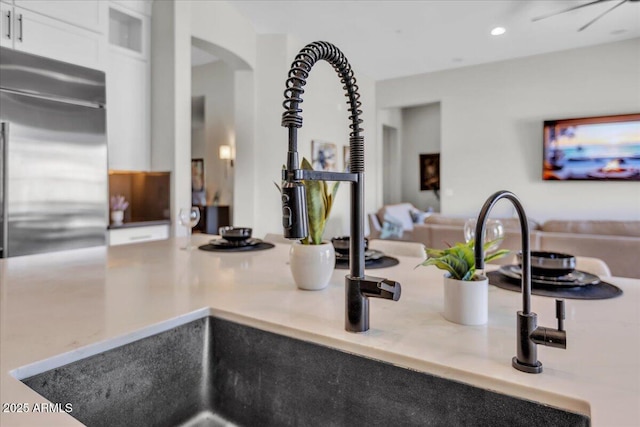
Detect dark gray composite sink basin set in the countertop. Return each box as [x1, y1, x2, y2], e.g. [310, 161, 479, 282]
[22, 317, 590, 427]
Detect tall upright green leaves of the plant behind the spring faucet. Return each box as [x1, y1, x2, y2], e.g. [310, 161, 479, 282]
[276, 158, 340, 245]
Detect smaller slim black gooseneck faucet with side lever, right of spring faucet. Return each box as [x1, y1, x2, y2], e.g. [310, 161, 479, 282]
[474, 190, 567, 374]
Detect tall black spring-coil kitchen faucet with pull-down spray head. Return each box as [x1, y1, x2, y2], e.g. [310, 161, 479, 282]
[282, 41, 400, 332]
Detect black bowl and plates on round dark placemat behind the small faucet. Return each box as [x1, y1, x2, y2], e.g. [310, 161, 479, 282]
[487, 251, 622, 299]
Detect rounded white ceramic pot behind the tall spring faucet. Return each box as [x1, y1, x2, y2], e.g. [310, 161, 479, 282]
[289, 242, 336, 291]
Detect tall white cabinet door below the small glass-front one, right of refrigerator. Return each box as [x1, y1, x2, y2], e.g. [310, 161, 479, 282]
[107, 48, 151, 171]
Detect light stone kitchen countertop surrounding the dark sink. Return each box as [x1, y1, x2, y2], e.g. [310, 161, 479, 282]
[0, 235, 640, 427]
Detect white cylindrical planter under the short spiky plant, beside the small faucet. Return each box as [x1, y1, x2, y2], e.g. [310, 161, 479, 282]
[443, 274, 489, 325]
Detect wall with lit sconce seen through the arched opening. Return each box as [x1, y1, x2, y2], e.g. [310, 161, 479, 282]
[191, 61, 235, 205]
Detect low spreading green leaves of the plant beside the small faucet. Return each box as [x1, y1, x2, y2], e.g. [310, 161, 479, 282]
[417, 239, 509, 281]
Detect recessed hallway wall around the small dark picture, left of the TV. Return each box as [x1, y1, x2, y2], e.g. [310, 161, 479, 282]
[401, 103, 441, 212]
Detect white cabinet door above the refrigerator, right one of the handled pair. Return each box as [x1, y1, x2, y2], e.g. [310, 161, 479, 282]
[13, 7, 104, 69]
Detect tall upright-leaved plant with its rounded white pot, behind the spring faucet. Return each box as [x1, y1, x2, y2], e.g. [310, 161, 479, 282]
[276, 158, 339, 290]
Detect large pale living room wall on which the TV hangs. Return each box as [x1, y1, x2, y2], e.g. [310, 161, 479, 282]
[376, 39, 640, 221]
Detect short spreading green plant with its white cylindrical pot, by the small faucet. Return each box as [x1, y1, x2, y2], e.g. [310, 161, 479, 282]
[416, 239, 509, 325]
